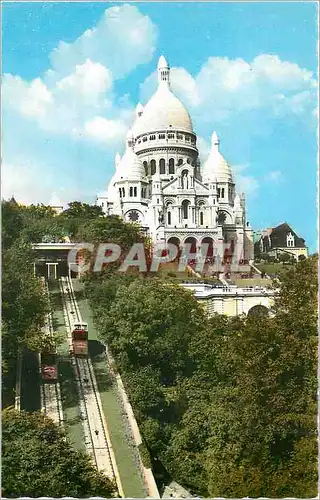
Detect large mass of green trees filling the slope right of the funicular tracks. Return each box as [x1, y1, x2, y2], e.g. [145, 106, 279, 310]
[87, 257, 317, 497]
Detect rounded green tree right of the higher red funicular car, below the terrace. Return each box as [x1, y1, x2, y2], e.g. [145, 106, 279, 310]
[101, 279, 205, 385]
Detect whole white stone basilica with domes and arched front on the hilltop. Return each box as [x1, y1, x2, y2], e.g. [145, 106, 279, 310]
[97, 56, 253, 260]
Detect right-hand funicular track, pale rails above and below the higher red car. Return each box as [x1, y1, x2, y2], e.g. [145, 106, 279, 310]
[59, 277, 124, 496]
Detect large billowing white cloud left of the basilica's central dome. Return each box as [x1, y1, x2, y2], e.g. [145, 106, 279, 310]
[3, 5, 157, 140]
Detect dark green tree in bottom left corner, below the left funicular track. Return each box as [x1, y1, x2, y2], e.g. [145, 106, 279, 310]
[2, 409, 115, 498]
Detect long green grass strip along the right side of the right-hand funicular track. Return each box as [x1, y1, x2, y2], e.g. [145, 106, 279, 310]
[73, 280, 146, 498]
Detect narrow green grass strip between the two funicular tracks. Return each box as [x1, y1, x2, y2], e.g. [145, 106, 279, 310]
[49, 281, 86, 450]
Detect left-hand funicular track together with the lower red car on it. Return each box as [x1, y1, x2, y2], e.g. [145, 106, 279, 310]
[40, 279, 63, 425]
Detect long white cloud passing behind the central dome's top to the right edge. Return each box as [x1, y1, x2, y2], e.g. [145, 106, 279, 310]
[141, 54, 317, 126]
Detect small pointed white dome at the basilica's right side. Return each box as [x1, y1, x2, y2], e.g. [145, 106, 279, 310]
[202, 132, 233, 182]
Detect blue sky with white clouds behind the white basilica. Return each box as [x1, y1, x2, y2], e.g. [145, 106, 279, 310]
[2, 2, 317, 251]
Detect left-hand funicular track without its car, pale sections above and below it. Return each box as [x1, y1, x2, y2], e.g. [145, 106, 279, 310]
[41, 279, 63, 425]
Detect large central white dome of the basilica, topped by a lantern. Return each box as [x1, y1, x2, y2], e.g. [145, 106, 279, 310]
[133, 56, 193, 137]
